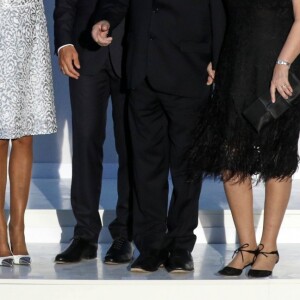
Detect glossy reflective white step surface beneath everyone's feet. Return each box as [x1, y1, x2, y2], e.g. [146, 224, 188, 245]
[0, 244, 300, 280]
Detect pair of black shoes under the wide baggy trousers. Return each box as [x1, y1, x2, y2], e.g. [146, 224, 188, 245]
[130, 249, 194, 273]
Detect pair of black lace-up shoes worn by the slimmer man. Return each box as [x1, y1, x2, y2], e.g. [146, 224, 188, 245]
[55, 237, 133, 264]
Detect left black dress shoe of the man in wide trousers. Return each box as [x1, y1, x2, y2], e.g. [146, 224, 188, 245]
[130, 251, 168, 272]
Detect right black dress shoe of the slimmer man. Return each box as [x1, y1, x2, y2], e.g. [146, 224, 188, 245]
[104, 238, 133, 265]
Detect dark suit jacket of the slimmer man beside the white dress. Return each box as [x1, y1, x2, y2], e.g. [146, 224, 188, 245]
[54, 0, 125, 76]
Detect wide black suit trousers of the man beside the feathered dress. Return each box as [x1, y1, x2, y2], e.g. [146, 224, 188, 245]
[129, 80, 210, 252]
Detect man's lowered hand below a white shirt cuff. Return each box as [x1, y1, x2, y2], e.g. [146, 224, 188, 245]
[58, 46, 80, 79]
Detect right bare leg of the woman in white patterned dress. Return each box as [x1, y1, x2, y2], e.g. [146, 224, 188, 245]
[9, 136, 33, 255]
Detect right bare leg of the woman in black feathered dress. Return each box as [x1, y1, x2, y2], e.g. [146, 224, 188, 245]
[252, 178, 292, 271]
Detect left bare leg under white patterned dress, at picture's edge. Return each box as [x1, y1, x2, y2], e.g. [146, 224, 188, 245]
[0, 140, 11, 257]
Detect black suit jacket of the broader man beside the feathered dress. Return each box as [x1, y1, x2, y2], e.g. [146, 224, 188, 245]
[96, 0, 225, 97]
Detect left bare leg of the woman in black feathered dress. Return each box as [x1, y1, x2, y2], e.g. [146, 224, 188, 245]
[224, 177, 257, 269]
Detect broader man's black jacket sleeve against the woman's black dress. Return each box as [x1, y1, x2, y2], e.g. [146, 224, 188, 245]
[210, 0, 226, 69]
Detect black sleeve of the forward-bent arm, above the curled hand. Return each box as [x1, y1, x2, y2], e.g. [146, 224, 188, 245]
[95, 0, 130, 30]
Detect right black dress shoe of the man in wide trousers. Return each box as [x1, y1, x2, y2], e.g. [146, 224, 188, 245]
[165, 249, 194, 273]
